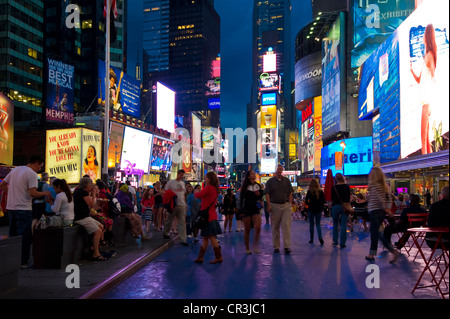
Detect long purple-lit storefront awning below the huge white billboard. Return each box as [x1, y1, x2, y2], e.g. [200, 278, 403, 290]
[381, 150, 449, 173]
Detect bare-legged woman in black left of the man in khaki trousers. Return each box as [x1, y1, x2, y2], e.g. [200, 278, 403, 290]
[240, 170, 263, 255]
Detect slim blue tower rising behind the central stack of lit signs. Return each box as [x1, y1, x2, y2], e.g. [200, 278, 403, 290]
[247, 0, 296, 172]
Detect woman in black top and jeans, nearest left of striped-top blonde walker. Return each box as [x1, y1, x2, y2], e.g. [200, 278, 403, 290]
[331, 173, 350, 248]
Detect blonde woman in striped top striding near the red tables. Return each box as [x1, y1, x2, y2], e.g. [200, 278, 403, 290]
[366, 167, 400, 263]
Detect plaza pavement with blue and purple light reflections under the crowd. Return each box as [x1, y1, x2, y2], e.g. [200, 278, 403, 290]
[0, 218, 448, 300]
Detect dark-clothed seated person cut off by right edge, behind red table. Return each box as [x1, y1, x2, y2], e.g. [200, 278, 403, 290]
[426, 186, 450, 252]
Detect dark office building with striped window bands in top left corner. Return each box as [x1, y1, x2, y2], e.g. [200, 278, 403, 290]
[0, 0, 44, 129]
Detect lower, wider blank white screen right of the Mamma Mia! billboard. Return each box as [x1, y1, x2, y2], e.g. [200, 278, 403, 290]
[120, 126, 153, 173]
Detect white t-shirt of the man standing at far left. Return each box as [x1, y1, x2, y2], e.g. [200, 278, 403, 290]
[4, 166, 38, 210]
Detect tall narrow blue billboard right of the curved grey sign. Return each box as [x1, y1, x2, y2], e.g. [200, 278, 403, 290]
[322, 12, 346, 138]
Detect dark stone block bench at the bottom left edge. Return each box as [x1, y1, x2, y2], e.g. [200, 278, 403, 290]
[0, 236, 22, 294]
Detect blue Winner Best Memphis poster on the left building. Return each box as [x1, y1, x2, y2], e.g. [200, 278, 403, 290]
[45, 58, 75, 124]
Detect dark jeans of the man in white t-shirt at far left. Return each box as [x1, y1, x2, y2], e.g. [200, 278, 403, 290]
[9, 210, 33, 265]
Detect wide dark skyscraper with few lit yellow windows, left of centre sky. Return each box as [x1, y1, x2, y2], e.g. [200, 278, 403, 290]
[142, 0, 220, 126]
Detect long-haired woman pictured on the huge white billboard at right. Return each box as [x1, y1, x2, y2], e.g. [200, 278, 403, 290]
[411, 24, 437, 154]
